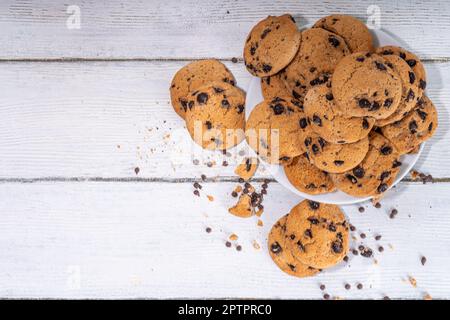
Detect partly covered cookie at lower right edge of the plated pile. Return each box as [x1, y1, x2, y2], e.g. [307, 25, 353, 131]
[330, 131, 401, 197]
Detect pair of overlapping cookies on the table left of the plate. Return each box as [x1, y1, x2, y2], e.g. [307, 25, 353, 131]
[170, 59, 245, 150]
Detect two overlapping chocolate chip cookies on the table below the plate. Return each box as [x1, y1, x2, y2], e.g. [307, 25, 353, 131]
[268, 200, 349, 278]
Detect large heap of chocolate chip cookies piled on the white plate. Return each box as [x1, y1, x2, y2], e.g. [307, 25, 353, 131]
[244, 14, 437, 197]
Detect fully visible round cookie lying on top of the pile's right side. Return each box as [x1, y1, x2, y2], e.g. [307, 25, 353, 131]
[331, 52, 402, 120]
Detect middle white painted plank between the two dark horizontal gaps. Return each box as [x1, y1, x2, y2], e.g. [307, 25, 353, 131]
[0, 62, 450, 178]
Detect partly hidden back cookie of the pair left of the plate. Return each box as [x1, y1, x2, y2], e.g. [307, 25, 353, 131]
[170, 59, 236, 119]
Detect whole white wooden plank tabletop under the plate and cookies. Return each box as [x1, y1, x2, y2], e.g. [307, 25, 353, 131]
[0, 0, 450, 299]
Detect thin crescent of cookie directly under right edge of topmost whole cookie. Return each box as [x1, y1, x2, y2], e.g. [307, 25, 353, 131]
[375, 55, 420, 127]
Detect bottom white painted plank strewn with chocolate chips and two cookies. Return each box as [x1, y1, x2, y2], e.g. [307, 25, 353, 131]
[0, 182, 450, 299]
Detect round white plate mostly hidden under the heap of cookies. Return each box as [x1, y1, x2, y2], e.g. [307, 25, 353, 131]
[245, 26, 424, 205]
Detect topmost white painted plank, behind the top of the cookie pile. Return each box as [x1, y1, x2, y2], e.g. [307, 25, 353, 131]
[0, 0, 450, 59]
